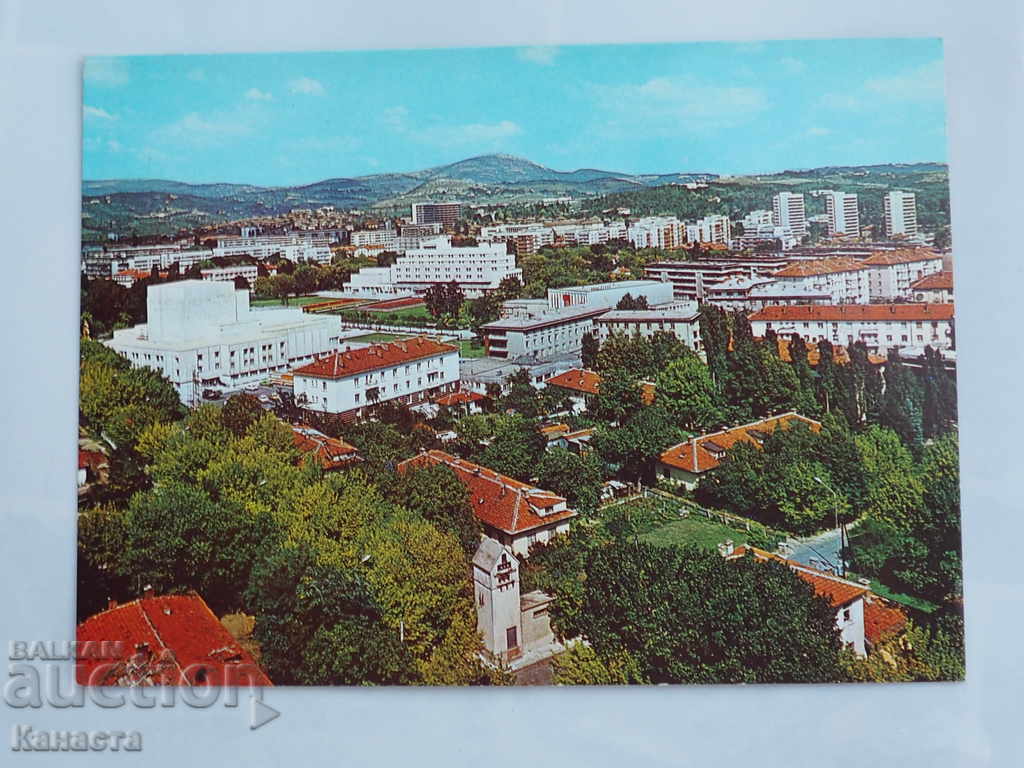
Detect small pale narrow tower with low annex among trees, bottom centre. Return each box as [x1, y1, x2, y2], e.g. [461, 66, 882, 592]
[473, 538, 562, 669]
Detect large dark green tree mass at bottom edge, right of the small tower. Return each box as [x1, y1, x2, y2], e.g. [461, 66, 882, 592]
[551, 542, 842, 683]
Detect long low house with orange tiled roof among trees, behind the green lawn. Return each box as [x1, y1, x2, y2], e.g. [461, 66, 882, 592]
[657, 412, 821, 490]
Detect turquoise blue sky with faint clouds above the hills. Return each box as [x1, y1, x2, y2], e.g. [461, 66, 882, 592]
[83, 39, 946, 185]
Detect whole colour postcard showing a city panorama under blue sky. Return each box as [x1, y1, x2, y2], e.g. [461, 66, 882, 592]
[77, 38, 965, 686]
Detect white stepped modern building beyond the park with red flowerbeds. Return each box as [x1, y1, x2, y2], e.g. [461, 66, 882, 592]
[344, 236, 522, 298]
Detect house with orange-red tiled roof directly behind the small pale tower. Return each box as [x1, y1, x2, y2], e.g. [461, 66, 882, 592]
[398, 451, 577, 557]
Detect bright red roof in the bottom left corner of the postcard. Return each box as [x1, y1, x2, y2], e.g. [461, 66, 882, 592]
[75, 588, 272, 686]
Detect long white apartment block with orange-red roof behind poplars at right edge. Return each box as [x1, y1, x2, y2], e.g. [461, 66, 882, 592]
[750, 303, 954, 355]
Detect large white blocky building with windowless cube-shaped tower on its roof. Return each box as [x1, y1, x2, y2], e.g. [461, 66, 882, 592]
[105, 281, 341, 404]
